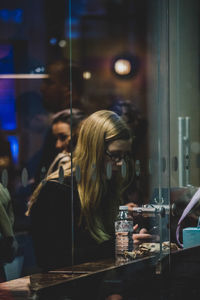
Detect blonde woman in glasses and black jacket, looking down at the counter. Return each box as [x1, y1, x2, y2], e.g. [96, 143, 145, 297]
[27, 110, 145, 269]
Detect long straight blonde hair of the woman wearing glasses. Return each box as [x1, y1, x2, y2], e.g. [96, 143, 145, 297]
[27, 110, 131, 242]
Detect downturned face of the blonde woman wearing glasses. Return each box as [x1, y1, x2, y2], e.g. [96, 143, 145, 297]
[105, 140, 131, 172]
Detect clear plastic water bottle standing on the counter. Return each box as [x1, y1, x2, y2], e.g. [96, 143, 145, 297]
[115, 206, 133, 263]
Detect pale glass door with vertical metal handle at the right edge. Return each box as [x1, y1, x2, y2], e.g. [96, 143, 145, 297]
[169, 1, 200, 244]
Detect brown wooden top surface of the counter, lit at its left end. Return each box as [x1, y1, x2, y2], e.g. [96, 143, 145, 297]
[0, 257, 156, 300]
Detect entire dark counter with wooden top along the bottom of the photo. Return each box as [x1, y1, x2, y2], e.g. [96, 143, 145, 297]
[0, 246, 200, 300]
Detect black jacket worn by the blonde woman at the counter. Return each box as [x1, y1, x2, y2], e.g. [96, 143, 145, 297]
[30, 178, 114, 269]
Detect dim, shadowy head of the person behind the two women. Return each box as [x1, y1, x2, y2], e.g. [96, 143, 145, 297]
[41, 58, 84, 113]
